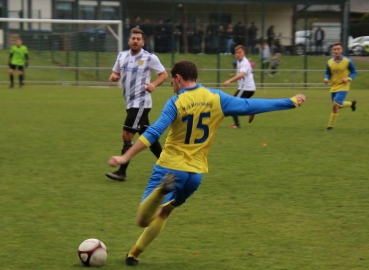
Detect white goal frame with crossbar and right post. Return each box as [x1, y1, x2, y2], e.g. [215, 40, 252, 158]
[0, 18, 123, 53]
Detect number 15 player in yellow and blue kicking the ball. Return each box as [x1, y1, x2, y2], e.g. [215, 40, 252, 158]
[108, 60, 305, 266]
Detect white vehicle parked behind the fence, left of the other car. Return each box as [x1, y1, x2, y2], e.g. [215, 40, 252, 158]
[295, 30, 334, 55]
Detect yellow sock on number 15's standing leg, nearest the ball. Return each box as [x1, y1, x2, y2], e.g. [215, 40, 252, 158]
[128, 216, 167, 260]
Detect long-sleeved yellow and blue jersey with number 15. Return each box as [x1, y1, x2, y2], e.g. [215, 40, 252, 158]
[139, 84, 297, 173]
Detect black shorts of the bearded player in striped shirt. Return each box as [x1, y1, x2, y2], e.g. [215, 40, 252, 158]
[123, 108, 151, 134]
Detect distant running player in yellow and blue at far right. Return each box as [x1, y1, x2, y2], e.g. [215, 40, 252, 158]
[324, 42, 357, 130]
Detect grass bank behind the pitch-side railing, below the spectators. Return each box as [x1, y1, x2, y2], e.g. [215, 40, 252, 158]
[0, 50, 369, 89]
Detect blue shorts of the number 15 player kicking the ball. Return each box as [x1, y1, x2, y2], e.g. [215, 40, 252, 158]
[141, 164, 202, 206]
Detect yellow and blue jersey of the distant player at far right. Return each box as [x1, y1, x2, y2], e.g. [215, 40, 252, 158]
[325, 56, 357, 92]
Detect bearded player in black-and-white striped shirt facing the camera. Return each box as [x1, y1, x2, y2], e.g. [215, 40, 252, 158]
[106, 28, 168, 181]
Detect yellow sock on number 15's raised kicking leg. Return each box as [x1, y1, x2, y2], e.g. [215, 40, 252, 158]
[138, 186, 165, 225]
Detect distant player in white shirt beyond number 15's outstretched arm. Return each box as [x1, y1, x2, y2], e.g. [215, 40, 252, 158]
[223, 45, 256, 128]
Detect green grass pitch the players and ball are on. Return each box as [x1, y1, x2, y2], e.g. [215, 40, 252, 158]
[0, 86, 369, 270]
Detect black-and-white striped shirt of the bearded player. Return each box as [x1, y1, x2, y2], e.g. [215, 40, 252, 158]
[113, 49, 165, 109]
